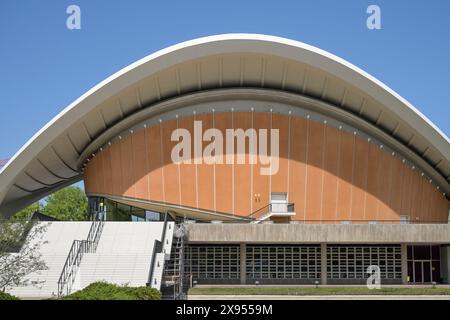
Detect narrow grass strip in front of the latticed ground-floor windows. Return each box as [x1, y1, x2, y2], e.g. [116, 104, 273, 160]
[188, 287, 450, 295]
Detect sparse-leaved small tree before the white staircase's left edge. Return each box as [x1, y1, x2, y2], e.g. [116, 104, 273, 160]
[0, 220, 47, 291]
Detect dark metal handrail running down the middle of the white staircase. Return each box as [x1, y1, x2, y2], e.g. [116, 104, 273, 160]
[58, 214, 104, 296]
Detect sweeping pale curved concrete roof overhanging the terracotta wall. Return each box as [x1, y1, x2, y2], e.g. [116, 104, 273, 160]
[0, 34, 450, 216]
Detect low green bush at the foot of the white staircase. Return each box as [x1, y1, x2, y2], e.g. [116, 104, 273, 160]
[64, 282, 161, 300]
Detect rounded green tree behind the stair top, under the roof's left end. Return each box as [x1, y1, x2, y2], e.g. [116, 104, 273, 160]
[42, 186, 88, 221]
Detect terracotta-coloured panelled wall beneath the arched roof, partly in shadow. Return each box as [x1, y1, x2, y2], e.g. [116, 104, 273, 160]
[84, 112, 450, 223]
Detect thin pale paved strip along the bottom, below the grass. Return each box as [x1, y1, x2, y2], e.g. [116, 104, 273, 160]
[188, 295, 450, 300]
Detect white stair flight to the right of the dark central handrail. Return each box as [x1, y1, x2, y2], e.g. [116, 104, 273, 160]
[72, 222, 173, 291]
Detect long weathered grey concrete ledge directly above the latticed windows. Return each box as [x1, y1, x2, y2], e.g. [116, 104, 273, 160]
[187, 223, 450, 244]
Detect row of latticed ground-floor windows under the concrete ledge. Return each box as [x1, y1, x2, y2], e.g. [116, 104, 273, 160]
[166, 245, 402, 279]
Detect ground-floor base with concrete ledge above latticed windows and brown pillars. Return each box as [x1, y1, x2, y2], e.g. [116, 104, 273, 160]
[187, 223, 450, 285]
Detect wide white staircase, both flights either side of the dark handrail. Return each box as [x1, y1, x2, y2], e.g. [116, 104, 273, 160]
[8, 222, 174, 299]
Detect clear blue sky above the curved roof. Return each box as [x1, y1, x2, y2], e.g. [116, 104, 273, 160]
[0, 0, 450, 159]
